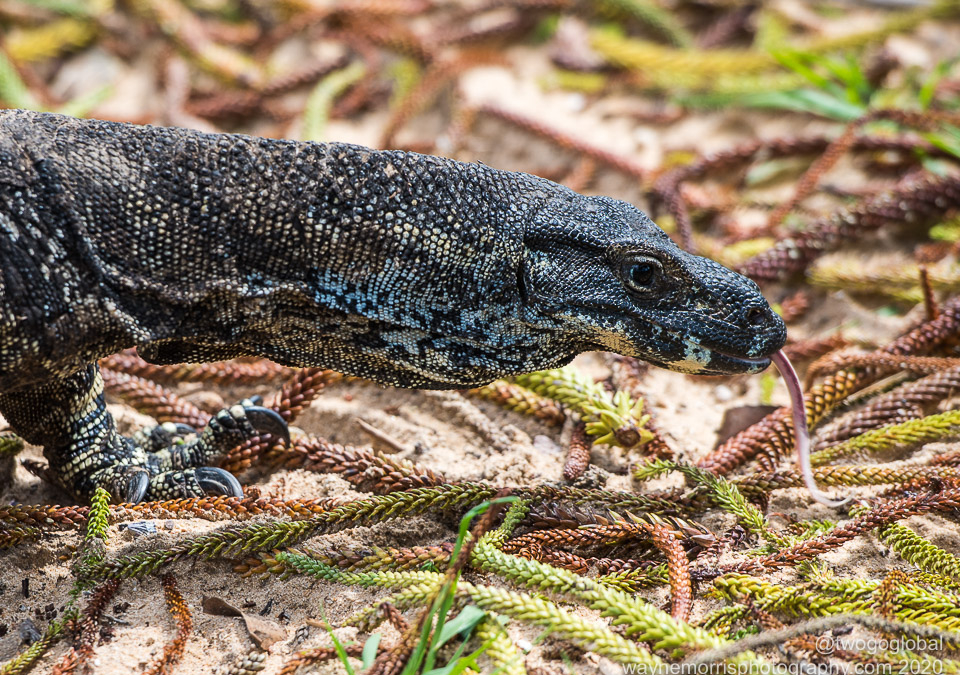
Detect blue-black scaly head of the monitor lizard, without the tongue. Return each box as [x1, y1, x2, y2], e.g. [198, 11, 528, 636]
[518, 193, 786, 375]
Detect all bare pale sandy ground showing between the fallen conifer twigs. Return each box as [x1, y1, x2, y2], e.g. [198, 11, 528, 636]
[0, 14, 960, 675]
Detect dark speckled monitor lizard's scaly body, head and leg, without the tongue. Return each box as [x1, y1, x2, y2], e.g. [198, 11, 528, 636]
[0, 110, 785, 501]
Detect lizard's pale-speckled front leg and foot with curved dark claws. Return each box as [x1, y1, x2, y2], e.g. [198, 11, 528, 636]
[0, 364, 287, 503]
